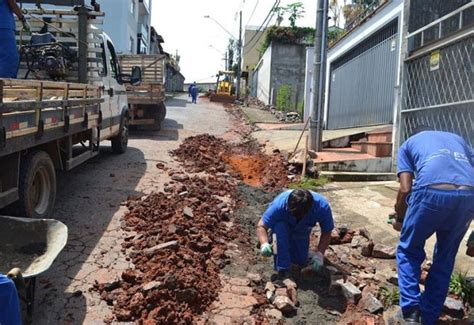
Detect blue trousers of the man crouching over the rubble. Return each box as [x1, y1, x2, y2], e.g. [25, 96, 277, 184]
[272, 222, 310, 271]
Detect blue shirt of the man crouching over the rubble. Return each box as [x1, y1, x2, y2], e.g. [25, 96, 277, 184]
[262, 191, 334, 239]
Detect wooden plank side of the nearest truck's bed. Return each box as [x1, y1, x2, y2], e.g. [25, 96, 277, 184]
[0, 79, 103, 157]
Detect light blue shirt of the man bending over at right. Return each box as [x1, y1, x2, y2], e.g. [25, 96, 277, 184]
[397, 131, 474, 189]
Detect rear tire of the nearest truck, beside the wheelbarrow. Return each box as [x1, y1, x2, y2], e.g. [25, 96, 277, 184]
[18, 151, 56, 218]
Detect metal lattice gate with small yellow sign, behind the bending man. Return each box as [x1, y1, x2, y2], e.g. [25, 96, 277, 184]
[401, 2, 474, 147]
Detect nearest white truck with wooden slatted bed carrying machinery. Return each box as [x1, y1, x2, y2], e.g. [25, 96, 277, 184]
[0, 6, 141, 218]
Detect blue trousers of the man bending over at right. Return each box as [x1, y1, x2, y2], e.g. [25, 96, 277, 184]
[397, 188, 474, 325]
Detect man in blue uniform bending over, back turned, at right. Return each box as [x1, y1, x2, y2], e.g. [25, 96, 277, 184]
[395, 127, 474, 325]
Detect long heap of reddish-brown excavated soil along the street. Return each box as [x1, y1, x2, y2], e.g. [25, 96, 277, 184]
[94, 135, 288, 324]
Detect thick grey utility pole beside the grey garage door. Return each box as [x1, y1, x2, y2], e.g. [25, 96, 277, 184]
[309, 0, 328, 152]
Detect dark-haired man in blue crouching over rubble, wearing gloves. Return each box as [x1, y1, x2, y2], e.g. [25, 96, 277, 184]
[257, 189, 334, 277]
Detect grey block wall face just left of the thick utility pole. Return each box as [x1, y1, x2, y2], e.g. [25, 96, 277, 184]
[270, 43, 306, 111]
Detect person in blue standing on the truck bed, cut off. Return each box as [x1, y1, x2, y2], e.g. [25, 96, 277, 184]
[0, 0, 27, 78]
